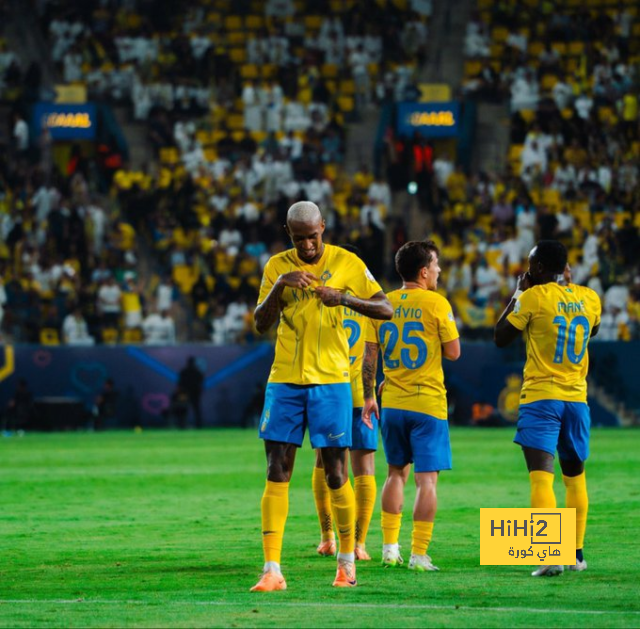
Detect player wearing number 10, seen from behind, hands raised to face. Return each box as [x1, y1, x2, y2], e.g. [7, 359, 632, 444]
[494, 240, 601, 577]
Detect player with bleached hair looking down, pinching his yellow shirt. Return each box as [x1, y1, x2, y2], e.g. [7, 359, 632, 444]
[252, 201, 392, 592]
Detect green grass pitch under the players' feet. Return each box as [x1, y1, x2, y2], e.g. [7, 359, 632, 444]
[0, 429, 640, 627]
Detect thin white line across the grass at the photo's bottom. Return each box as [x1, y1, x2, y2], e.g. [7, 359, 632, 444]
[0, 598, 640, 616]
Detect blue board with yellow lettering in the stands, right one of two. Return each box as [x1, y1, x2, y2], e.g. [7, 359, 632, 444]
[397, 101, 460, 138]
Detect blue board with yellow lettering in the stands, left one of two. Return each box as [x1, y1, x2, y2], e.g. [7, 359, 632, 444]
[33, 103, 98, 140]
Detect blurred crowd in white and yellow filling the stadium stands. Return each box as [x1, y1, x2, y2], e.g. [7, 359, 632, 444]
[0, 0, 640, 345]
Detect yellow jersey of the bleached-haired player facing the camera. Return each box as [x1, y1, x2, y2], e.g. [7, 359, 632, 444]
[258, 244, 382, 384]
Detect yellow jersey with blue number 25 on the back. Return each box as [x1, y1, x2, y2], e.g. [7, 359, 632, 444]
[365, 288, 459, 419]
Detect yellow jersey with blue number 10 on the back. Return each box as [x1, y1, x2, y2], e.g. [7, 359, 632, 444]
[507, 282, 602, 404]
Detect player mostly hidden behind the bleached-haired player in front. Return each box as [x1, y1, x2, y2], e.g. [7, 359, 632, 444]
[311, 245, 378, 561]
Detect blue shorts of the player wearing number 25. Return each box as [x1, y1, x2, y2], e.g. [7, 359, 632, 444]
[382, 408, 451, 472]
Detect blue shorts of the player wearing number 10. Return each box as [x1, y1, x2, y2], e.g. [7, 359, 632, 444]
[513, 400, 591, 461]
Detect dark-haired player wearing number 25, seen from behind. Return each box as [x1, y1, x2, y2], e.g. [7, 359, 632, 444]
[362, 241, 460, 572]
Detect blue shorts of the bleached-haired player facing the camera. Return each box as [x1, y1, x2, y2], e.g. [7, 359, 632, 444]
[258, 382, 353, 448]
